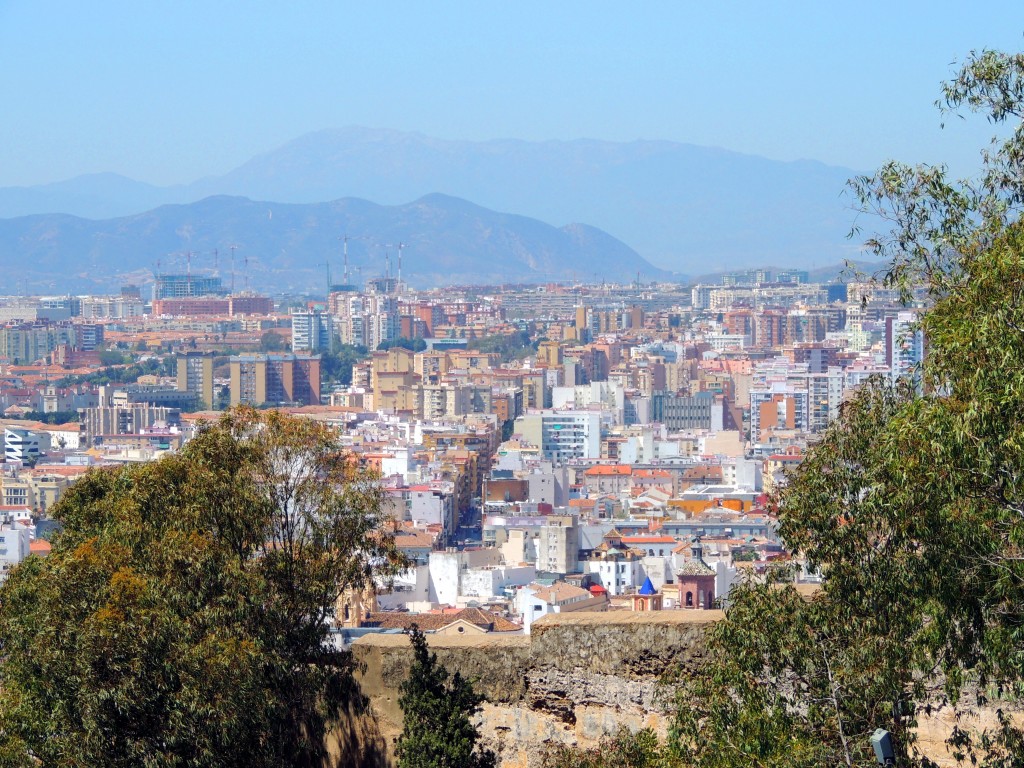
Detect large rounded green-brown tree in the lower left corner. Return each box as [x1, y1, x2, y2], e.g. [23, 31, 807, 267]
[0, 409, 402, 768]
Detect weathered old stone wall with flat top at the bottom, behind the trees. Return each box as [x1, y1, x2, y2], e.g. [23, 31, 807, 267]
[335, 610, 994, 768]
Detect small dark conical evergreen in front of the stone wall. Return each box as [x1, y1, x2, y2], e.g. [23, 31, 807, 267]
[395, 627, 496, 768]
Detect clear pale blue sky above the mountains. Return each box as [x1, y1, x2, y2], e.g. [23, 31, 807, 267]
[0, 0, 1024, 186]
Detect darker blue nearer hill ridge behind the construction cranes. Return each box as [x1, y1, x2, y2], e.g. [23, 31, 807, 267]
[0, 195, 667, 292]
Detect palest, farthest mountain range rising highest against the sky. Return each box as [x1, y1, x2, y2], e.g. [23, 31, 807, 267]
[0, 128, 858, 273]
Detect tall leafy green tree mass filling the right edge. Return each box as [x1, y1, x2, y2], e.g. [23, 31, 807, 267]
[673, 52, 1024, 767]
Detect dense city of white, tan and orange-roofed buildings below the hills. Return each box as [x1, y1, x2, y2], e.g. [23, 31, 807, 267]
[0, 270, 924, 630]
